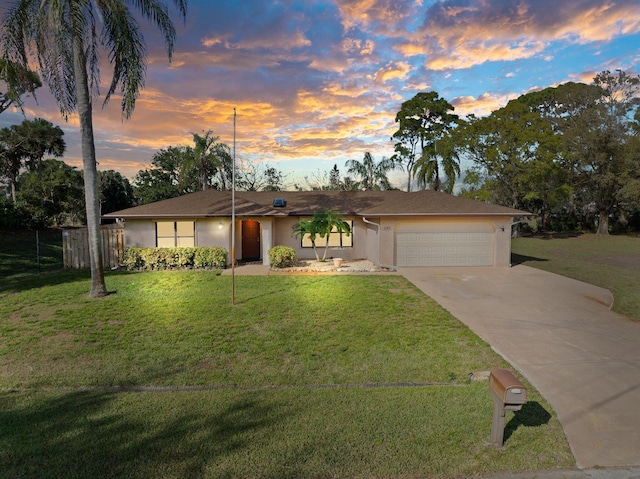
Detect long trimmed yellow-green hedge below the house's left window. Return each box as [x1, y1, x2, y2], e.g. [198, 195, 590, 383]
[123, 247, 227, 270]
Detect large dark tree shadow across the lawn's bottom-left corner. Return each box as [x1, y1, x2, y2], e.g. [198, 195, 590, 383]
[0, 391, 273, 478]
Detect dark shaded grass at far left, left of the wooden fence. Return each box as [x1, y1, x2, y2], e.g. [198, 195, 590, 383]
[0, 230, 63, 288]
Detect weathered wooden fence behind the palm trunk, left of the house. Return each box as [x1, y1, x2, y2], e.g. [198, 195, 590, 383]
[62, 224, 124, 269]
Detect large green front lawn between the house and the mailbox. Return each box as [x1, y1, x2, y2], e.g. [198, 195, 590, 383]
[0, 271, 574, 478]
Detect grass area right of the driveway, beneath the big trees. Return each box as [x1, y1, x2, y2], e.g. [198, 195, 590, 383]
[512, 234, 640, 321]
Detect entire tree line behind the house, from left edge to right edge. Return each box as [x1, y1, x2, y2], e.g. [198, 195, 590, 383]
[0, 71, 640, 234]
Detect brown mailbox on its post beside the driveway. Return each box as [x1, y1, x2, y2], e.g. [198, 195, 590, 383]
[489, 369, 527, 447]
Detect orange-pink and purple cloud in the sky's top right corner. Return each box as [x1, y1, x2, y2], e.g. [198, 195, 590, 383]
[396, 0, 640, 70]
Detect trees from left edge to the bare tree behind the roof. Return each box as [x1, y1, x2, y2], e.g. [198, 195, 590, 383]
[0, 124, 284, 229]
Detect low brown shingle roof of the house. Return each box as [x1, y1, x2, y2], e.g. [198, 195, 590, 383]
[104, 190, 530, 218]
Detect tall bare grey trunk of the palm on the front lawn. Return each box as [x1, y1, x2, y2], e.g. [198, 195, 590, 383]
[73, 31, 107, 298]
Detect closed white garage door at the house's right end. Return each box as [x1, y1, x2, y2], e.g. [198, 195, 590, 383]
[396, 225, 495, 266]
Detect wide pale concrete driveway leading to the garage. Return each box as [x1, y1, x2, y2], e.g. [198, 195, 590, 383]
[399, 266, 640, 468]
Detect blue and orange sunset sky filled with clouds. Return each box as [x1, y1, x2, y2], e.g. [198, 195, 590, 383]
[0, 0, 640, 187]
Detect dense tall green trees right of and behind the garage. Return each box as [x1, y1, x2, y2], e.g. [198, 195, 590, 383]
[384, 70, 640, 235]
